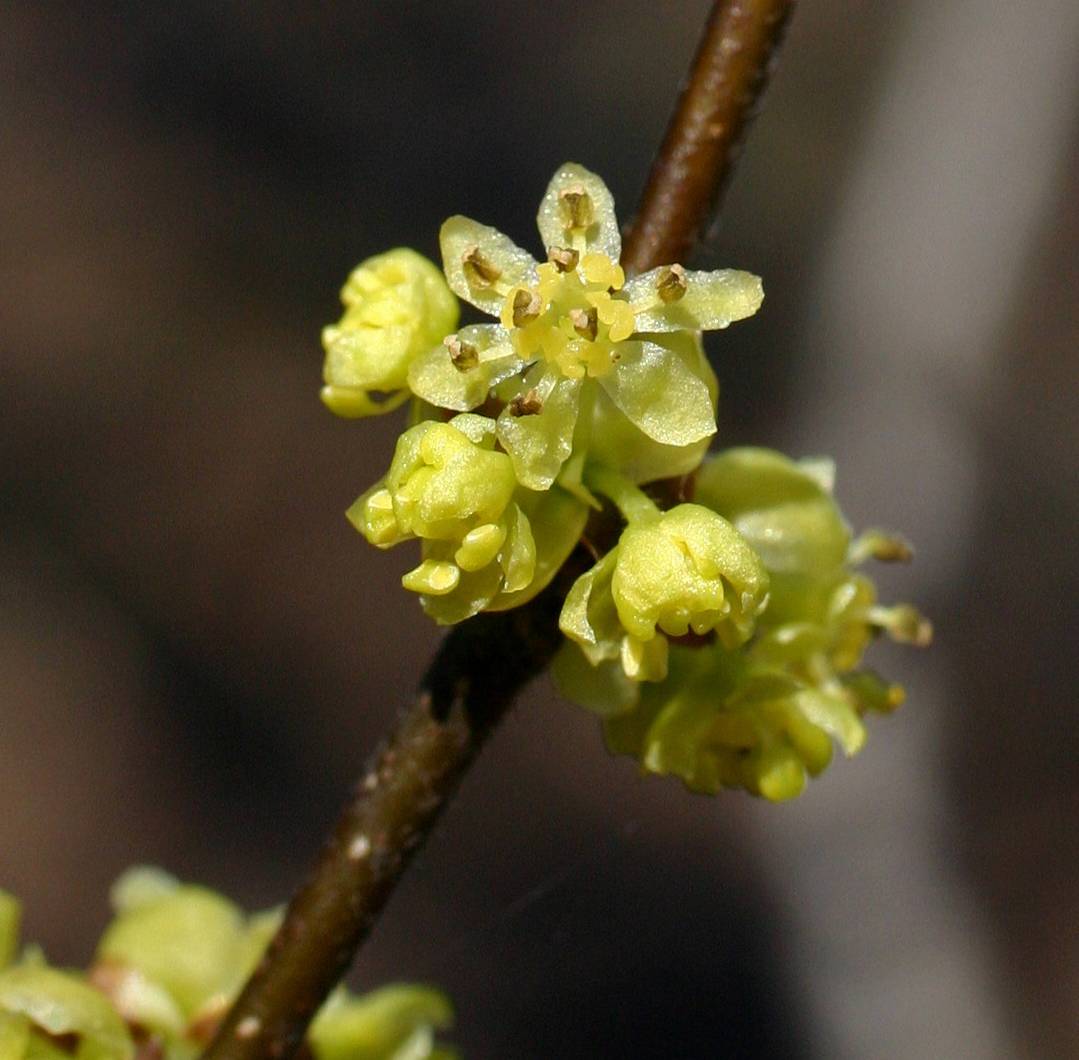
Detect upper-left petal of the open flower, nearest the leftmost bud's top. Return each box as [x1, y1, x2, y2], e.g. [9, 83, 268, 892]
[438, 214, 536, 316]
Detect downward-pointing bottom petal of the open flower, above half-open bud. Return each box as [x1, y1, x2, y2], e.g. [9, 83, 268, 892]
[498, 369, 582, 490]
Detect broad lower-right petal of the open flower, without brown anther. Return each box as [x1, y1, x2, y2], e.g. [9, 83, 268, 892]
[599, 339, 715, 446]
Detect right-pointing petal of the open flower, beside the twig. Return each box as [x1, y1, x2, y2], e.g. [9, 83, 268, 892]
[624, 266, 764, 331]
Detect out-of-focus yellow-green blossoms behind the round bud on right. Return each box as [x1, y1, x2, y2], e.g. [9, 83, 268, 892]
[556, 449, 930, 800]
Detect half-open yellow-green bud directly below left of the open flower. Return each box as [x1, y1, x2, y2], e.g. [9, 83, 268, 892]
[349, 413, 586, 624]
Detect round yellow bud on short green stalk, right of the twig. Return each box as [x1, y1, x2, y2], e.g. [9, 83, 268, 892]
[559, 504, 768, 681]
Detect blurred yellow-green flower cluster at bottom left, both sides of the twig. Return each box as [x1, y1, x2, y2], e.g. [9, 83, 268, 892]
[0, 869, 456, 1060]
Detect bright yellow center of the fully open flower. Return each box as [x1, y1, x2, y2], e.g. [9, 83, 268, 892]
[502, 247, 636, 379]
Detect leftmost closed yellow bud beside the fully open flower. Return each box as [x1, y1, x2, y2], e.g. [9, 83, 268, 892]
[322, 247, 459, 419]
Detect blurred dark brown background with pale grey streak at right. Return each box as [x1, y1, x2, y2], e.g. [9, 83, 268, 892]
[0, 0, 1079, 1060]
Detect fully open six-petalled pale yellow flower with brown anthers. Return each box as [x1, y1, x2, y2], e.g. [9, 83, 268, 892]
[409, 163, 764, 490]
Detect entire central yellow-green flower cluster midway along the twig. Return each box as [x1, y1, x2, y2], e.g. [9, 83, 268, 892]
[323, 164, 928, 799]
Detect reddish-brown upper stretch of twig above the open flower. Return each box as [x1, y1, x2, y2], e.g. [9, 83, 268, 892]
[622, 0, 794, 273]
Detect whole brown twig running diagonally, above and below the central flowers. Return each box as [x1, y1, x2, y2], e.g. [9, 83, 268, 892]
[204, 0, 792, 1060]
